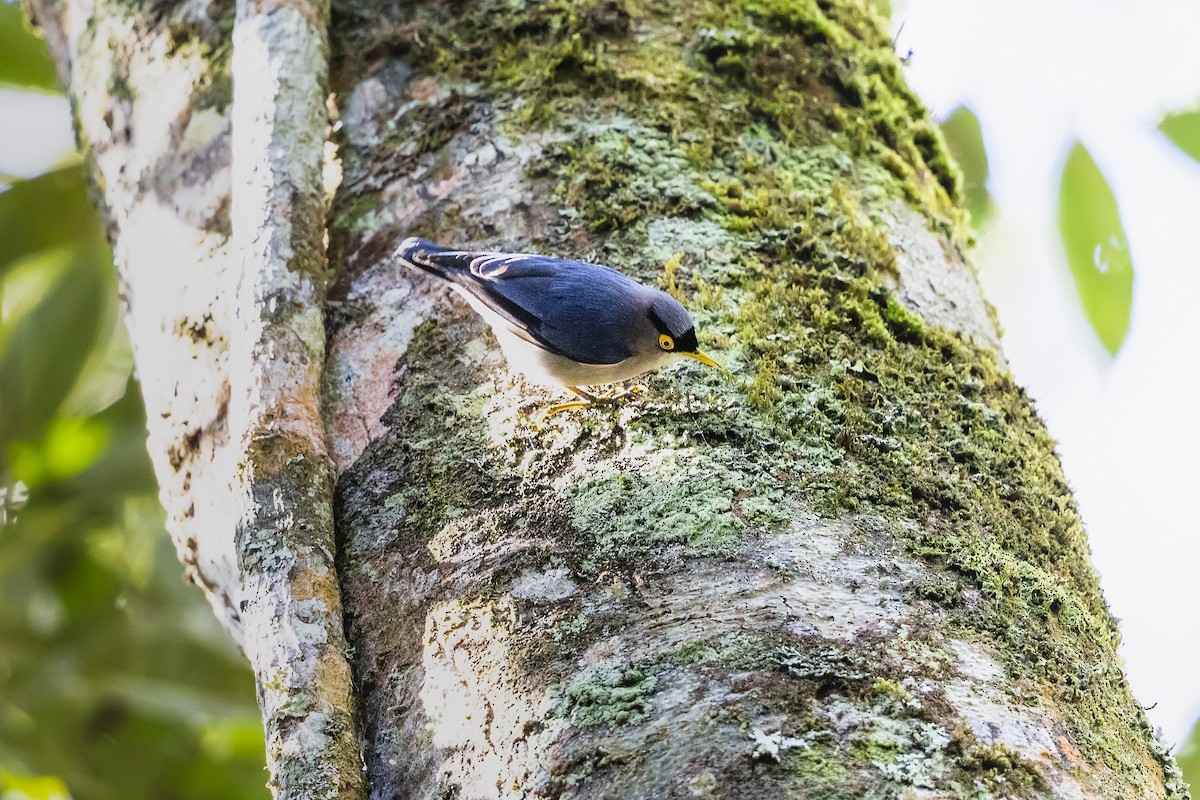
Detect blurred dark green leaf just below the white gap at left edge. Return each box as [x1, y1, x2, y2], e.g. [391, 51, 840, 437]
[0, 165, 103, 277]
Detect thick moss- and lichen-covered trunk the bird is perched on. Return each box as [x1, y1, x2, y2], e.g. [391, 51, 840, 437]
[328, 0, 1186, 798]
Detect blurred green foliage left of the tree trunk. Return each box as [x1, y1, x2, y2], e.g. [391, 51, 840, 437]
[0, 14, 269, 800]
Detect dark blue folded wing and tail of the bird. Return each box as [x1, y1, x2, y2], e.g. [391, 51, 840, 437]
[396, 240, 637, 363]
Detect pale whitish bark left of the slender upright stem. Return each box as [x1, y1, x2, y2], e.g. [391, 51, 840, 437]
[32, 0, 241, 642]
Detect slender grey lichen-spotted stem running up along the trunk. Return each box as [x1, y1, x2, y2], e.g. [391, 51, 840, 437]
[229, 0, 364, 799]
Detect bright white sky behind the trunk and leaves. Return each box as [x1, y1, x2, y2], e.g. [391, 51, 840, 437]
[7, 0, 1200, 758]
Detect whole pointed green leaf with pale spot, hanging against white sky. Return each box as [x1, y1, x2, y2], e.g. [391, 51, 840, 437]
[1058, 142, 1134, 355]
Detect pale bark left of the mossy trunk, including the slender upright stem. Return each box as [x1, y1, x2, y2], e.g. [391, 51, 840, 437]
[36, 0, 362, 799]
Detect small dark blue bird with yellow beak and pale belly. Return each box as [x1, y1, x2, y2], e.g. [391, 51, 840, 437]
[394, 236, 727, 415]
